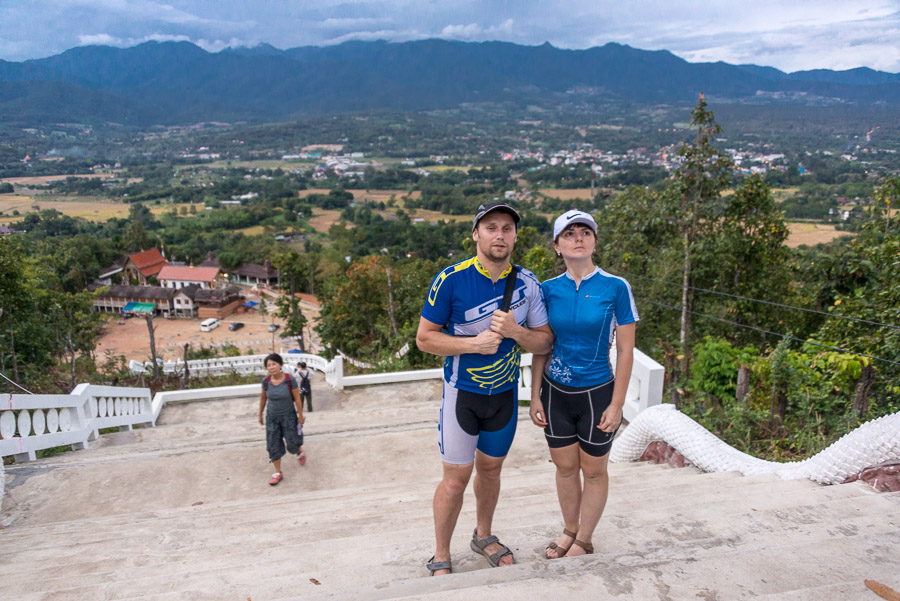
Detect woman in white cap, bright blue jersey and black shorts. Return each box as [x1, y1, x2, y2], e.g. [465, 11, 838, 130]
[530, 210, 638, 559]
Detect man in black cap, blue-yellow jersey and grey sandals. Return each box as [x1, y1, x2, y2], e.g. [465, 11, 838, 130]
[416, 202, 553, 575]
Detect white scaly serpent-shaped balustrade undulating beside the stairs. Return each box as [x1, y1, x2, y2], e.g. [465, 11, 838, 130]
[610, 405, 900, 484]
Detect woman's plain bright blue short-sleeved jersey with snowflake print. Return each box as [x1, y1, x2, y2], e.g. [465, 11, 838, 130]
[541, 267, 640, 387]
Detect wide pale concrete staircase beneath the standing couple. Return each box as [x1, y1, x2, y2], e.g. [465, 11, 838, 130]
[0, 384, 900, 601]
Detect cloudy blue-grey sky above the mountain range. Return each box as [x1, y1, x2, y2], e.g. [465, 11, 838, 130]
[0, 0, 900, 73]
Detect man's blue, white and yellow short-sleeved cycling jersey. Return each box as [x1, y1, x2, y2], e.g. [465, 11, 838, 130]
[422, 257, 548, 394]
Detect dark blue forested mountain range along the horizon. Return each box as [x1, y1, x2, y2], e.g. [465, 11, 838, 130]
[0, 40, 900, 125]
